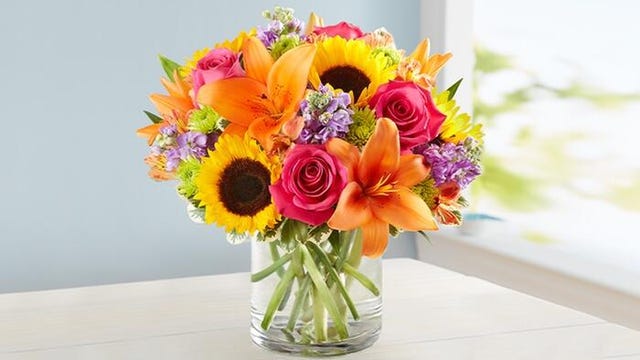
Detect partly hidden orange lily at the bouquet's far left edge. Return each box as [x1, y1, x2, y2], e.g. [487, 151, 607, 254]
[136, 70, 194, 145]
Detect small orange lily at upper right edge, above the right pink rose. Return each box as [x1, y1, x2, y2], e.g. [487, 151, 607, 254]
[398, 39, 453, 90]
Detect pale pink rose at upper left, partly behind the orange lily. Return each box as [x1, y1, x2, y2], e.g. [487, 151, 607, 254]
[191, 48, 244, 100]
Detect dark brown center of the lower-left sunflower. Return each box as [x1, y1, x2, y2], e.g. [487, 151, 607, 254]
[218, 159, 271, 216]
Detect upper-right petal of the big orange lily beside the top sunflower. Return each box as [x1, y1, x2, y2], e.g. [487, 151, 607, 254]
[267, 44, 316, 112]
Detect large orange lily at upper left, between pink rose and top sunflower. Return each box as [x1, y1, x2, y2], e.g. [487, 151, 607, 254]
[198, 37, 315, 151]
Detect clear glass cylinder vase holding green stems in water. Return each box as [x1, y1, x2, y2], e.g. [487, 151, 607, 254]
[251, 231, 382, 356]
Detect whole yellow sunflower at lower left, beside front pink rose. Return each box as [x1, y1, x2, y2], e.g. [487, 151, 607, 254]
[194, 135, 281, 233]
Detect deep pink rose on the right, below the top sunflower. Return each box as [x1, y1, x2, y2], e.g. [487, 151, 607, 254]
[369, 81, 446, 151]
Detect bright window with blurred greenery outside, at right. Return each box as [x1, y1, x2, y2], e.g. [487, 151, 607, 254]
[473, 0, 640, 273]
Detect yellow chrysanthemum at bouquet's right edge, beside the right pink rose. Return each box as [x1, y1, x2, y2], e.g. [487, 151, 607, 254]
[433, 91, 484, 144]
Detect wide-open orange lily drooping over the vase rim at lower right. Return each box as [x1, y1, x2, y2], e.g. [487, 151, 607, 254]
[326, 118, 438, 257]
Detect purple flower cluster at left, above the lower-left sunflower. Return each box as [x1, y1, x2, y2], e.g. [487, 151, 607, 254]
[151, 125, 218, 171]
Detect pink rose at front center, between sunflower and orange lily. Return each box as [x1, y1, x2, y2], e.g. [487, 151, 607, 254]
[269, 145, 347, 226]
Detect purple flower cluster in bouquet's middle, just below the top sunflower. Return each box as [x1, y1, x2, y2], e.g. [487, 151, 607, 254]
[298, 85, 353, 144]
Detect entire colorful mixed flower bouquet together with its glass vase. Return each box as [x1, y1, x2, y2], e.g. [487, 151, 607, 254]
[138, 8, 482, 355]
